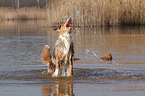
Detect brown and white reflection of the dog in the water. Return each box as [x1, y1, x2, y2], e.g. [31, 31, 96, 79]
[42, 80, 75, 96]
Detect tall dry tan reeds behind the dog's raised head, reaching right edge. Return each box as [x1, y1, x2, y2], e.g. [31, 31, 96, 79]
[47, 0, 145, 26]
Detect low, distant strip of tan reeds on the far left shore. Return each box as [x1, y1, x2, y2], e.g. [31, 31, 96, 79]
[0, 7, 47, 20]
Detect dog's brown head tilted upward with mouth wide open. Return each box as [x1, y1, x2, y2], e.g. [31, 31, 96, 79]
[57, 18, 72, 35]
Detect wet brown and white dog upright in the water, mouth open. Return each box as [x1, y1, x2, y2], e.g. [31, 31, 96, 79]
[41, 18, 74, 76]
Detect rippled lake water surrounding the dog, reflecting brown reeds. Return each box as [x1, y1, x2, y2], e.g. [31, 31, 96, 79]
[0, 21, 145, 96]
